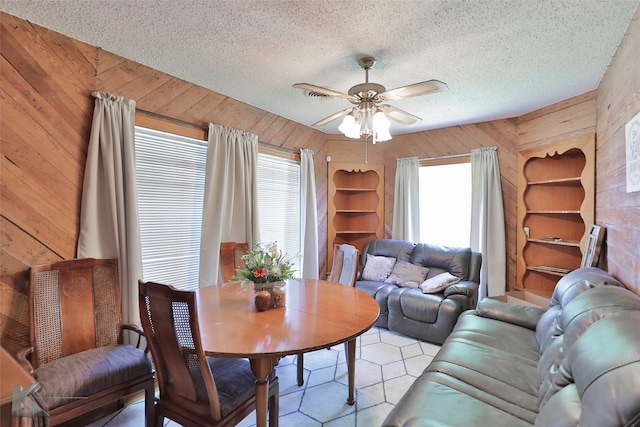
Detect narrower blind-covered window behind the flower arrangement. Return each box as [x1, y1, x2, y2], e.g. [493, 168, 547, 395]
[258, 154, 302, 276]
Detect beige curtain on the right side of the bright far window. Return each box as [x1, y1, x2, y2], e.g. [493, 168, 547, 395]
[471, 147, 507, 301]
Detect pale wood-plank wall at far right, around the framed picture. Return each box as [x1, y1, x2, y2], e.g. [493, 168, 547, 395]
[596, 8, 640, 294]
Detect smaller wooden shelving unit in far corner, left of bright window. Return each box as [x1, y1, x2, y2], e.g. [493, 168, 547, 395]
[327, 162, 384, 269]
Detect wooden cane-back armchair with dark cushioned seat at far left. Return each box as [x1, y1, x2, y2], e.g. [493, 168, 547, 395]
[18, 259, 155, 426]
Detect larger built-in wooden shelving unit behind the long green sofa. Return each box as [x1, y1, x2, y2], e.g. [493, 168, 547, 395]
[517, 135, 595, 297]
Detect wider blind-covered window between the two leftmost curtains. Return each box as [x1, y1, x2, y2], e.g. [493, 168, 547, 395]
[135, 123, 207, 289]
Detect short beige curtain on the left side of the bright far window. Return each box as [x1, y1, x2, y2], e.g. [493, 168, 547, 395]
[392, 157, 420, 242]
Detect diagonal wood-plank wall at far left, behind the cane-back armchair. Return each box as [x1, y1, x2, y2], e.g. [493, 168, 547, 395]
[0, 13, 96, 352]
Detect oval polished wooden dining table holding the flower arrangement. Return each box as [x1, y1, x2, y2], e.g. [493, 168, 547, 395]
[196, 280, 380, 427]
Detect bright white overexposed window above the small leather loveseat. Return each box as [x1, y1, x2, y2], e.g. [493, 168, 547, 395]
[419, 162, 471, 247]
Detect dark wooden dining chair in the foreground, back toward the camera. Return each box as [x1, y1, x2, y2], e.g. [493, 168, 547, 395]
[139, 281, 279, 427]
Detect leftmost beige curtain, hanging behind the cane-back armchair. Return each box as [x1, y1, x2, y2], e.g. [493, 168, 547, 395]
[77, 92, 142, 323]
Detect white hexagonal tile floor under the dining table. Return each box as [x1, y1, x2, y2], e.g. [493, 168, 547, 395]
[90, 327, 440, 427]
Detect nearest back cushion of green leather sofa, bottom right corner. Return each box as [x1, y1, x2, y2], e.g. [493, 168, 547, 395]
[536, 310, 640, 427]
